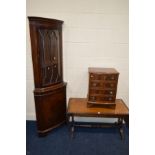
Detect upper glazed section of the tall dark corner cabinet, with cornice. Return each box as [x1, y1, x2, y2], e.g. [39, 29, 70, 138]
[28, 17, 63, 88]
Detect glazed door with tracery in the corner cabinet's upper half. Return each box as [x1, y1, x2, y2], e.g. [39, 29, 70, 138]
[38, 28, 62, 87]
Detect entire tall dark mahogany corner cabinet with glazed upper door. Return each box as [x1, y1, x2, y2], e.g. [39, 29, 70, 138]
[28, 17, 66, 135]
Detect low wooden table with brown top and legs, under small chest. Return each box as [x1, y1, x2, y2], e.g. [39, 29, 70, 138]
[67, 98, 129, 140]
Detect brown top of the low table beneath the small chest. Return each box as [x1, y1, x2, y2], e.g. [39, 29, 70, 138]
[67, 98, 129, 117]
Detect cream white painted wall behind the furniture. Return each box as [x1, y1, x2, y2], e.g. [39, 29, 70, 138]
[26, 0, 129, 120]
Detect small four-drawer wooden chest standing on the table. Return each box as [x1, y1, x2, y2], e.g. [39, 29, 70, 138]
[87, 68, 119, 106]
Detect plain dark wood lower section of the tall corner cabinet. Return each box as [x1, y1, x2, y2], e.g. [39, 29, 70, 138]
[34, 86, 66, 135]
